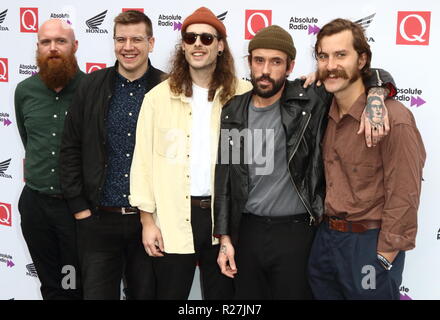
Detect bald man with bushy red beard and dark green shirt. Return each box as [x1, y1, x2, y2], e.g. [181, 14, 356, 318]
[15, 19, 84, 300]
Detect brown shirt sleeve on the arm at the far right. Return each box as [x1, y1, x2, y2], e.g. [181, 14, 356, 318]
[377, 124, 426, 252]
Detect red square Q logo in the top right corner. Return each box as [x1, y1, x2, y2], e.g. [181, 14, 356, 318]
[396, 11, 431, 46]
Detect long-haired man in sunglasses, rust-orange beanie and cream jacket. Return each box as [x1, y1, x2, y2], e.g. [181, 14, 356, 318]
[129, 7, 251, 299]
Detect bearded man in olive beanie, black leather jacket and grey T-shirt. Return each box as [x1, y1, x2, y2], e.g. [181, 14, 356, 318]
[214, 26, 396, 299]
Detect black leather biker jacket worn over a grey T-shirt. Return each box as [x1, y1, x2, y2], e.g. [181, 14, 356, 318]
[214, 71, 394, 242]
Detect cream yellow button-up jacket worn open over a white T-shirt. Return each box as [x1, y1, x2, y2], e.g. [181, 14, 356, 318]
[129, 80, 252, 254]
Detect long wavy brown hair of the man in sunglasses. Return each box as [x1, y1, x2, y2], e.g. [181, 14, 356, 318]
[169, 38, 237, 104]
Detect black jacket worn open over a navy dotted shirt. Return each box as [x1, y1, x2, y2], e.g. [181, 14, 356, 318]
[60, 61, 164, 213]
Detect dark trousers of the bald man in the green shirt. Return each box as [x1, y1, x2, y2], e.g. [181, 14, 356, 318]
[18, 186, 81, 300]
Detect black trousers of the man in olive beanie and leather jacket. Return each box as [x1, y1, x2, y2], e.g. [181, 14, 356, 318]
[235, 214, 315, 299]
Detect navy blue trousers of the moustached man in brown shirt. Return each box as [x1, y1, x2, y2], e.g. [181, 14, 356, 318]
[309, 222, 405, 300]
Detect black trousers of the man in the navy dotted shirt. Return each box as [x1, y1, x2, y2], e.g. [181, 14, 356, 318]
[76, 211, 155, 300]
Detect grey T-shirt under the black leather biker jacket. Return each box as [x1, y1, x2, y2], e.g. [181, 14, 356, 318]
[245, 100, 307, 216]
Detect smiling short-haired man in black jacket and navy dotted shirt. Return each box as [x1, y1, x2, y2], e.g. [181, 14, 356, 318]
[60, 11, 163, 299]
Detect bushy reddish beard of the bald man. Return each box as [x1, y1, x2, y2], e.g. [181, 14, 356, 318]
[37, 49, 78, 90]
